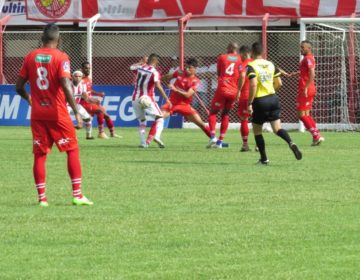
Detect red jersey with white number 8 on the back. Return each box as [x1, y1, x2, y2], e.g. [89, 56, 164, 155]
[19, 48, 71, 120]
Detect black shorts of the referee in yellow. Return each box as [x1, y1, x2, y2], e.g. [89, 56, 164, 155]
[252, 94, 280, 124]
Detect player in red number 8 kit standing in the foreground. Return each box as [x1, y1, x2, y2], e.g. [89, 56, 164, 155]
[16, 23, 93, 207]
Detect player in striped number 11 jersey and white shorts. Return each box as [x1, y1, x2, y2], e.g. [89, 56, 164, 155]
[130, 54, 171, 148]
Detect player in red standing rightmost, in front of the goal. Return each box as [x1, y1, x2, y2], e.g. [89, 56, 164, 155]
[297, 40, 325, 146]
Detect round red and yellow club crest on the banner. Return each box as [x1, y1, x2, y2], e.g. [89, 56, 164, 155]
[35, 0, 71, 18]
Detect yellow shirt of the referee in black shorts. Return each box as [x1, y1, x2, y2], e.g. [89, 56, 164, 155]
[246, 58, 281, 98]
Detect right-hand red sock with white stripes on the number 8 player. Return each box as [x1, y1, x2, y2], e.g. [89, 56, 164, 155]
[67, 149, 82, 198]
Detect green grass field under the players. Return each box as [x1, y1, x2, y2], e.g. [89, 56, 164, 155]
[0, 127, 360, 280]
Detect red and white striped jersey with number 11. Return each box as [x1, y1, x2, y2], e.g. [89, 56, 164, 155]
[132, 64, 160, 101]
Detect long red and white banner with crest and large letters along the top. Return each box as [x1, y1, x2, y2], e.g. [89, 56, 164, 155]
[26, 0, 360, 25]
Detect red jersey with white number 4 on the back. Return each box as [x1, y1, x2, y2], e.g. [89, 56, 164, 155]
[217, 53, 242, 94]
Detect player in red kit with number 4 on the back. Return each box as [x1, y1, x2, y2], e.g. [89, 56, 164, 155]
[208, 43, 241, 148]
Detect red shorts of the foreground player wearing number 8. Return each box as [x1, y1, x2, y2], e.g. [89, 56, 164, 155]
[31, 118, 78, 154]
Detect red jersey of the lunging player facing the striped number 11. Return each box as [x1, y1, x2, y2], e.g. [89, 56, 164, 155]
[170, 70, 200, 105]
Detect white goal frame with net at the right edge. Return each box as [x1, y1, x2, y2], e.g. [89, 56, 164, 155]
[300, 18, 360, 131]
